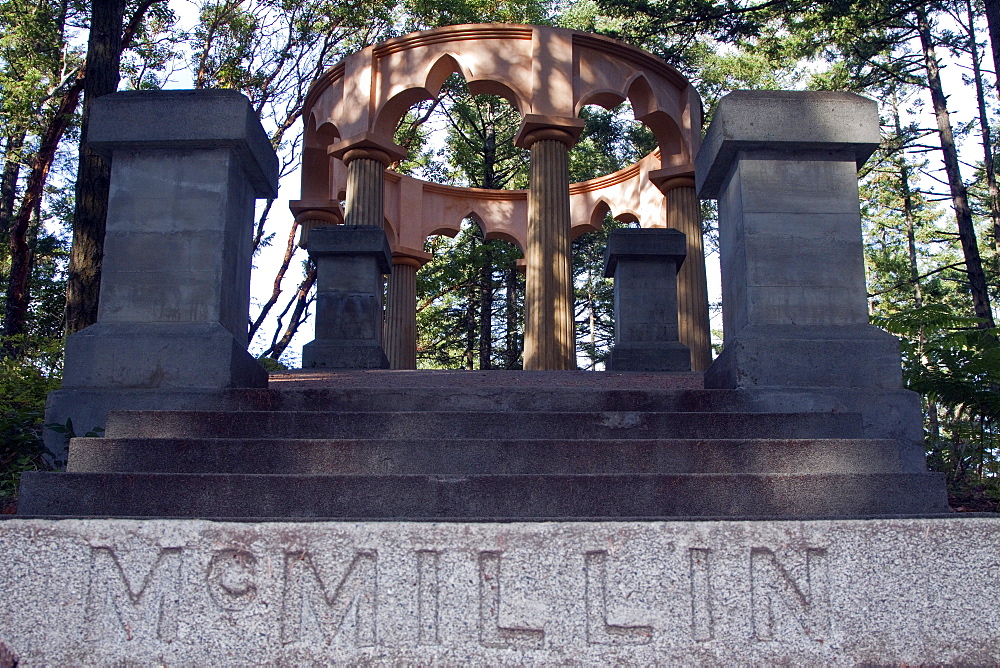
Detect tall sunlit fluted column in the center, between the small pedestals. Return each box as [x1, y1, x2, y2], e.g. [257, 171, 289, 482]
[524, 128, 576, 370]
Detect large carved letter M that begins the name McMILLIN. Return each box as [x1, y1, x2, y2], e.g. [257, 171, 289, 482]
[84, 547, 181, 642]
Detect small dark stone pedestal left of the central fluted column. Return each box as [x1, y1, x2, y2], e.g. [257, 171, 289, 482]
[302, 225, 392, 369]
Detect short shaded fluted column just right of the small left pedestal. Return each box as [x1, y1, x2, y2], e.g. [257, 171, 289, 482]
[382, 253, 430, 369]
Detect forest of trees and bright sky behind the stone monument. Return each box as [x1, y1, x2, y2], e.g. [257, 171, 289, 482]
[0, 0, 1000, 512]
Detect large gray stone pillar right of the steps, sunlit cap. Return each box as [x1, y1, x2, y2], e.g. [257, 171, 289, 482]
[697, 91, 901, 389]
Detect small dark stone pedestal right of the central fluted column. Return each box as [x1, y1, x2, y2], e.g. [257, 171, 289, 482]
[604, 229, 691, 371]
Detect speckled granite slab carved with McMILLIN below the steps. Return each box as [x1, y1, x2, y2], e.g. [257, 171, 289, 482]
[0, 518, 1000, 666]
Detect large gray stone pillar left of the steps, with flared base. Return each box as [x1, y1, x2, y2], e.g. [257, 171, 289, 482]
[63, 90, 278, 388]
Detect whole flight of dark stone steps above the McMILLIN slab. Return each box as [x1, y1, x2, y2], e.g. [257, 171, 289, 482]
[19, 371, 947, 521]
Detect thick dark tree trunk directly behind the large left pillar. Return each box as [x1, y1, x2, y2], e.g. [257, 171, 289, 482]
[66, 0, 125, 333]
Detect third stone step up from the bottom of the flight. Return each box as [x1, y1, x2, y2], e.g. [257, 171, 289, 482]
[105, 411, 862, 440]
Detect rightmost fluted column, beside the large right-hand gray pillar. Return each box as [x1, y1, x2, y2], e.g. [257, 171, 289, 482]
[660, 172, 712, 371]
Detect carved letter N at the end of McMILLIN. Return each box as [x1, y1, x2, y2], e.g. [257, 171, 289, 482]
[750, 547, 830, 641]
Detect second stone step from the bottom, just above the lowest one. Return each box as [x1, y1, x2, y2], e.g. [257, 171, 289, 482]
[68, 438, 904, 475]
